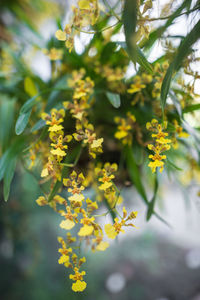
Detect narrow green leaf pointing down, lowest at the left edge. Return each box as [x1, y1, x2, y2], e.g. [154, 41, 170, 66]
[3, 157, 17, 201]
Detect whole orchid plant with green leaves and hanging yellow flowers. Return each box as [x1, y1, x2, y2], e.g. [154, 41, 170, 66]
[0, 0, 200, 292]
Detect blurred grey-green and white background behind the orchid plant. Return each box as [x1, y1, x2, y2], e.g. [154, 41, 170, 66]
[0, 0, 200, 300]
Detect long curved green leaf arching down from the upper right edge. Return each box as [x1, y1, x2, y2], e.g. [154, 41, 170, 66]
[161, 21, 200, 112]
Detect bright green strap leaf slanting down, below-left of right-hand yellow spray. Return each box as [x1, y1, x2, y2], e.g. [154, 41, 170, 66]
[125, 146, 148, 204]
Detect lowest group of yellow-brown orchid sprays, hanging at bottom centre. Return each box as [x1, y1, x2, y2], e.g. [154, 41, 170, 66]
[36, 168, 137, 292]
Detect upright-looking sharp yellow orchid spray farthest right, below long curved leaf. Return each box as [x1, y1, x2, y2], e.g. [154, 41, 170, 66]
[146, 119, 171, 173]
